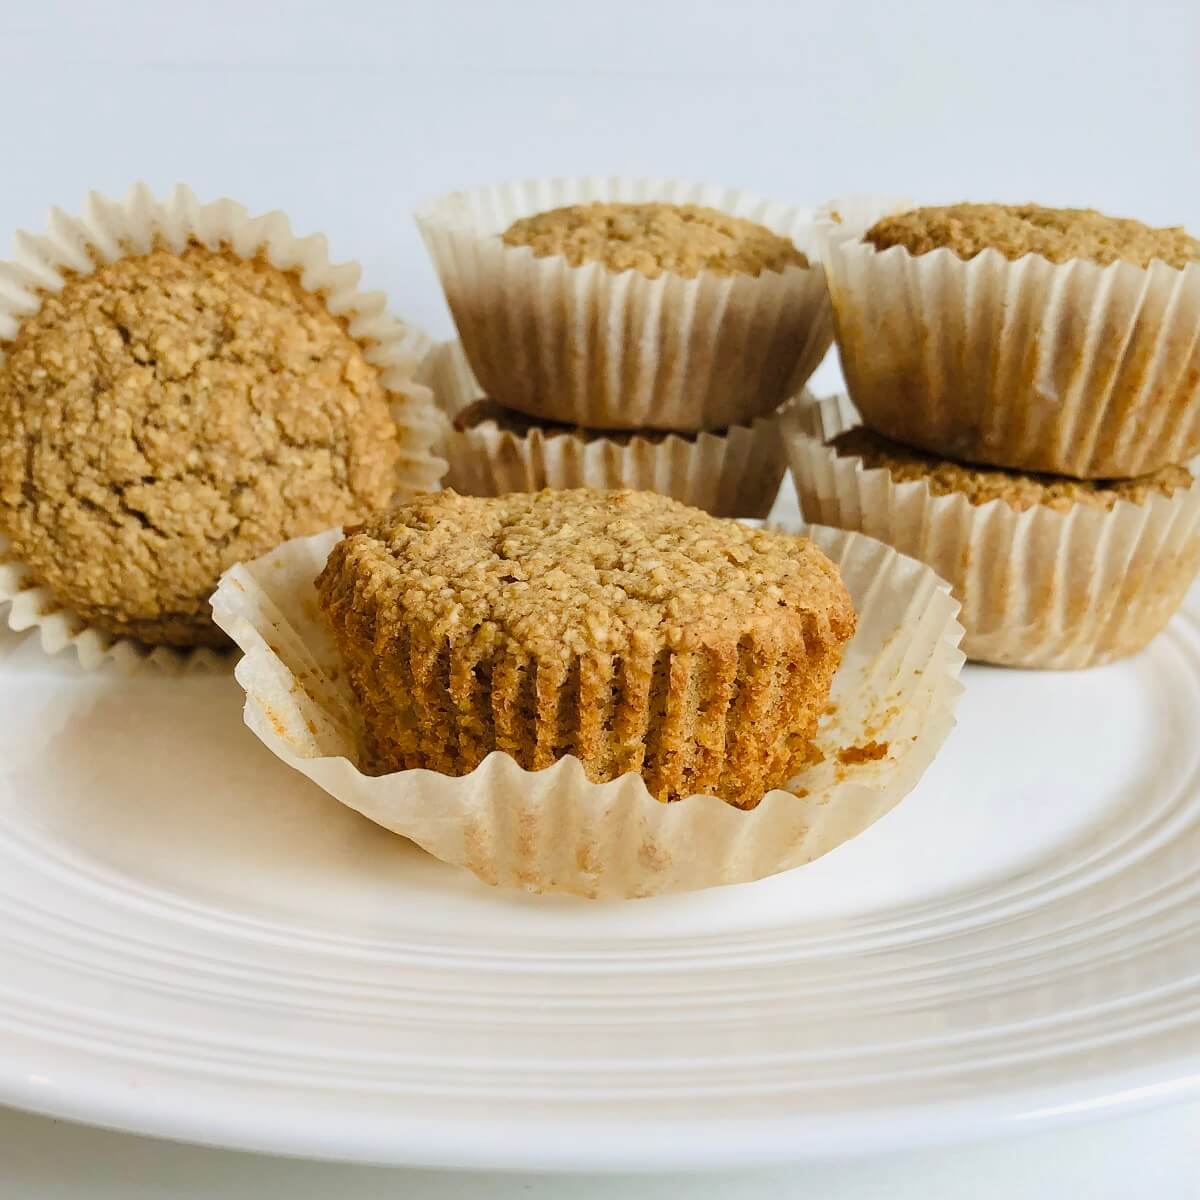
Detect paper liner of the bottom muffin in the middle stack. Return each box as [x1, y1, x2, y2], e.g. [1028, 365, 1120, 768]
[430, 342, 787, 517]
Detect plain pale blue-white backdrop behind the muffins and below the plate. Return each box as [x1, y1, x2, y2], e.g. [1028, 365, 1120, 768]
[0, 0, 1200, 1200]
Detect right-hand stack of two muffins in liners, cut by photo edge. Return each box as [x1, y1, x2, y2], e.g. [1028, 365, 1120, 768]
[786, 204, 1200, 667]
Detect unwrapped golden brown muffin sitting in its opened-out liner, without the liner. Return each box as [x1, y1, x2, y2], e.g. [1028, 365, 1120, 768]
[317, 488, 854, 808]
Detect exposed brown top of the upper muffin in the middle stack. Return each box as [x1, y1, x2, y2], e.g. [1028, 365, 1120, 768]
[503, 203, 809, 278]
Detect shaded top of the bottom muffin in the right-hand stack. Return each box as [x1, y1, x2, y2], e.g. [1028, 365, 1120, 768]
[830, 427, 1194, 512]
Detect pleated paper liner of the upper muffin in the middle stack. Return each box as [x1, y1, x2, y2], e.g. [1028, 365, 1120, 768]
[416, 179, 833, 432]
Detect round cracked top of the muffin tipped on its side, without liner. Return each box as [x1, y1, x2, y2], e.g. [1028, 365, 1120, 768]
[0, 245, 398, 646]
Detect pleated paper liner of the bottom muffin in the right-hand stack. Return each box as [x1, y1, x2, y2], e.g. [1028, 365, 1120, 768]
[782, 396, 1200, 668]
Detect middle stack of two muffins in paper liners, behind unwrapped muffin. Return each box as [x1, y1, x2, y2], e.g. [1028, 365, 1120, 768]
[418, 180, 833, 516]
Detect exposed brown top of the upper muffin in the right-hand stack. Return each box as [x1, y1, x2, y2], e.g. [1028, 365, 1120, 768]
[865, 204, 1200, 266]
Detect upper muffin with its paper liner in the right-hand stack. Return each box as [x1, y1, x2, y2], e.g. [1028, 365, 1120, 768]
[823, 204, 1200, 479]
